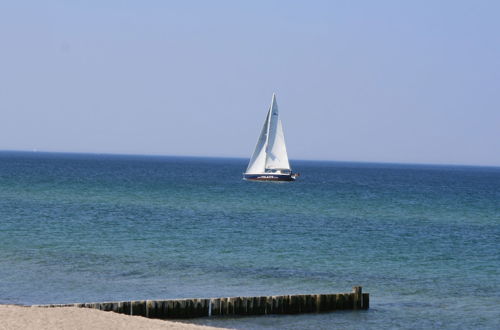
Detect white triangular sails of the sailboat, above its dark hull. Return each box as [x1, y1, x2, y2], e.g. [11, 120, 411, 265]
[246, 94, 290, 174]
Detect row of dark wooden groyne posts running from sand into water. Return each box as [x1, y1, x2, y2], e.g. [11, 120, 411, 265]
[34, 286, 370, 319]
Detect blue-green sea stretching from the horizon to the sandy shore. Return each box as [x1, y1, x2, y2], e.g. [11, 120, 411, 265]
[0, 152, 500, 329]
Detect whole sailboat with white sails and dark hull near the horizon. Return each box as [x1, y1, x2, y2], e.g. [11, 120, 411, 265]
[243, 93, 298, 181]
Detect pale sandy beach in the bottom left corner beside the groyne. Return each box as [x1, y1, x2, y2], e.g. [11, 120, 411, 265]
[0, 305, 225, 330]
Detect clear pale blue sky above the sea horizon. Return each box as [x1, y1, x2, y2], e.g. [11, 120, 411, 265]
[0, 0, 500, 166]
